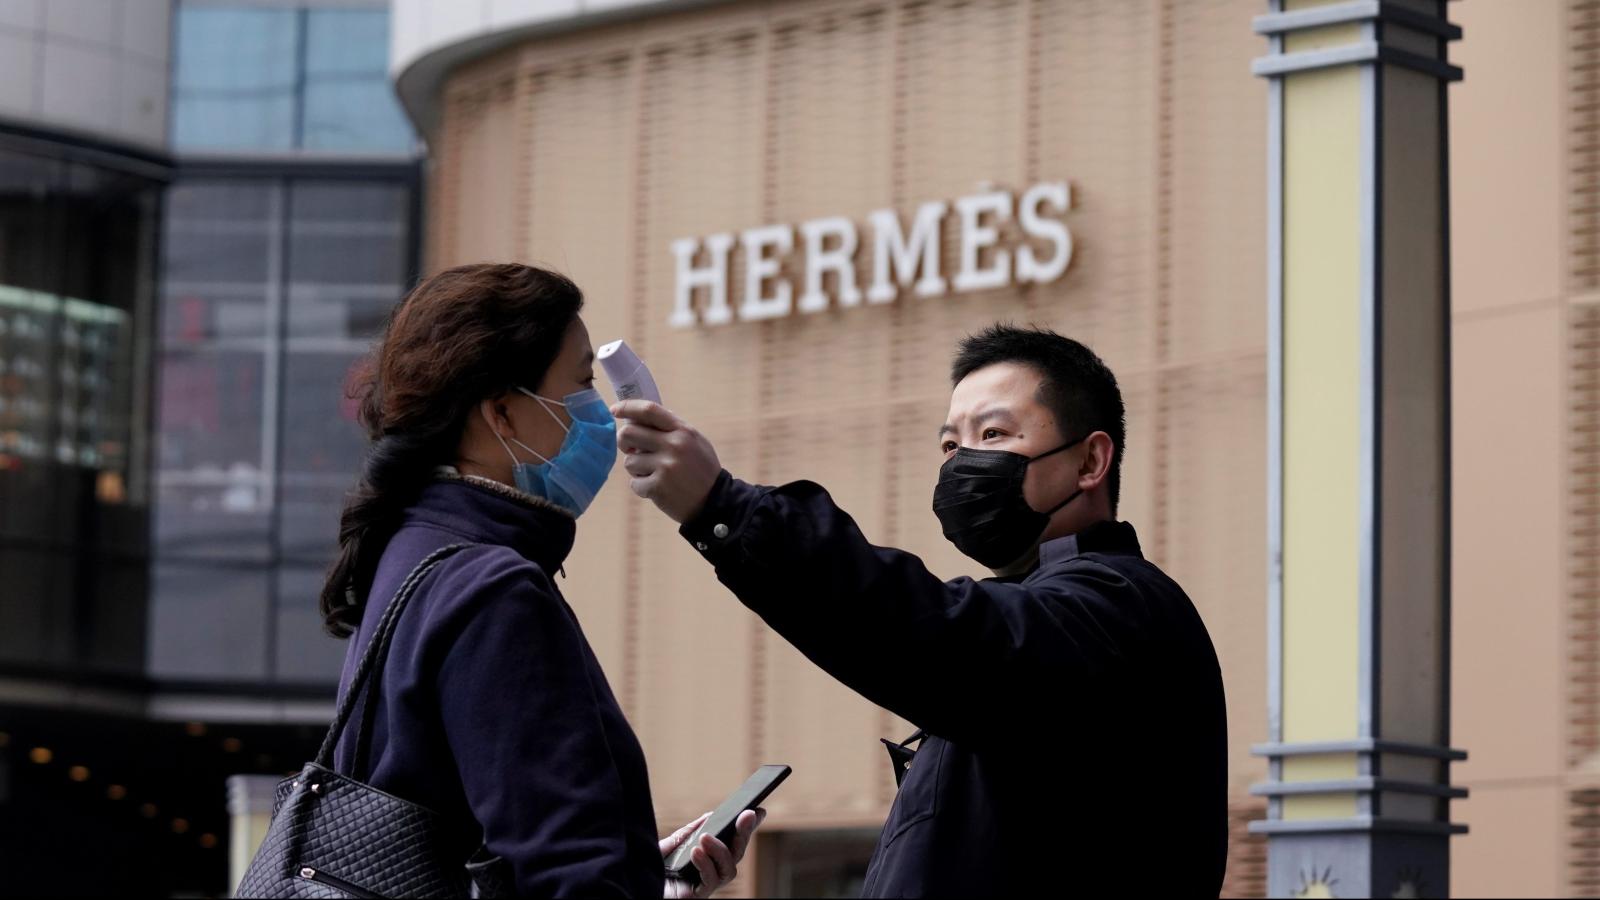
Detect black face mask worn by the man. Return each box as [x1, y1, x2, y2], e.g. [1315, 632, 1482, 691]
[933, 434, 1088, 569]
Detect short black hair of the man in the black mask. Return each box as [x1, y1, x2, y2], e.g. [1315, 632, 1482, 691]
[950, 323, 1128, 516]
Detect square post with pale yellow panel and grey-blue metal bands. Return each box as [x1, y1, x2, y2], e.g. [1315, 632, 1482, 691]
[1251, 0, 1466, 897]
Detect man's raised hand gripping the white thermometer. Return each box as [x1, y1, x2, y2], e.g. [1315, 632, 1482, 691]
[611, 400, 722, 525]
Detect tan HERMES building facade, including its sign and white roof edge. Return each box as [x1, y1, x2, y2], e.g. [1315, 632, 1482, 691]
[394, 0, 1574, 895]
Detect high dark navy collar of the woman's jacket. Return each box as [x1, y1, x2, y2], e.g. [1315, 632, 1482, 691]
[405, 468, 578, 573]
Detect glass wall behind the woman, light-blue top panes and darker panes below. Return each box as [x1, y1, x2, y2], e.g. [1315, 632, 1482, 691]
[150, 0, 419, 690]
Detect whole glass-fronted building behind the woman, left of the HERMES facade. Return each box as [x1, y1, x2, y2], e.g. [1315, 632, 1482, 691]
[0, 0, 421, 895]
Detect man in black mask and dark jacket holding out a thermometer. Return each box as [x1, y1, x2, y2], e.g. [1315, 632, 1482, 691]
[613, 325, 1227, 897]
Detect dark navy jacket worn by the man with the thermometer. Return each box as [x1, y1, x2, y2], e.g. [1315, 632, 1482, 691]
[683, 472, 1227, 897]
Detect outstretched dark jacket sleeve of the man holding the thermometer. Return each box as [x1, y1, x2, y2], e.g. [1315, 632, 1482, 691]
[682, 472, 1142, 746]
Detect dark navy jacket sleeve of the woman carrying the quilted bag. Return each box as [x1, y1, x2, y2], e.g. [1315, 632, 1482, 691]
[435, 551, 638, 897]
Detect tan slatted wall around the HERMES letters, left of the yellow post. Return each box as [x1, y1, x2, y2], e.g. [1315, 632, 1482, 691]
[429, 0, 1286, 897]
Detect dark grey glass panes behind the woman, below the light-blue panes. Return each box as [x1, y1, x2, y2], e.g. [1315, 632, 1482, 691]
[150, 168, 416, 682]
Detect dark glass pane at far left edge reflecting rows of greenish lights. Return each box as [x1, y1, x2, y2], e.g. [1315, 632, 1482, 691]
[0, 147, 158, 512]
